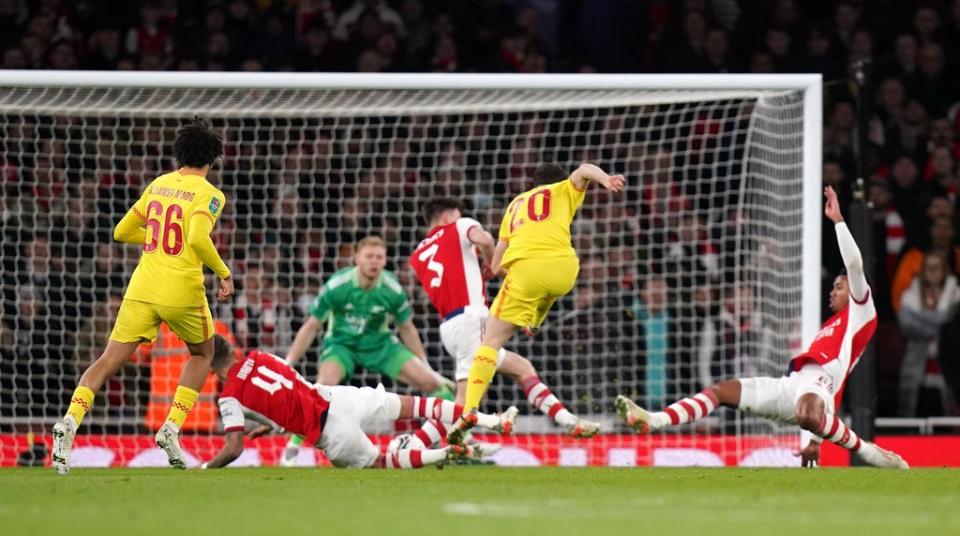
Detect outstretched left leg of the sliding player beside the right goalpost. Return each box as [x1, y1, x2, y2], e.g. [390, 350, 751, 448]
[616, 378, 740, 434]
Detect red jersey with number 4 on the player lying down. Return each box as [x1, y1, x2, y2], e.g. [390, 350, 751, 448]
[219, 350, 330, 445]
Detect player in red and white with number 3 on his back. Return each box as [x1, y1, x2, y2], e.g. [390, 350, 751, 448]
[410, 198, 600, 440]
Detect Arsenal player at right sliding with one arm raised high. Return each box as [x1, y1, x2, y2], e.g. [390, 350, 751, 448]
[616, 187, 907, 469]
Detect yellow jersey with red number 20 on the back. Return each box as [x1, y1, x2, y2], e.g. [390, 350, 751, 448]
[500, 178, 584, 268]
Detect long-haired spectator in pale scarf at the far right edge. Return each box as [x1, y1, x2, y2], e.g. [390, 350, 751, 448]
[897, 251, 960, 417]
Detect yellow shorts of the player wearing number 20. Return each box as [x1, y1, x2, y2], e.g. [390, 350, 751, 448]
[490, 257, 580, 328]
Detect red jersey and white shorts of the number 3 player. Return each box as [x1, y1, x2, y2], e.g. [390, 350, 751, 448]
[410, 218, 506, 381]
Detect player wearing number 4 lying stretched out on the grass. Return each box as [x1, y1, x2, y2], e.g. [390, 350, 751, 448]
[202, 335, 517, 469]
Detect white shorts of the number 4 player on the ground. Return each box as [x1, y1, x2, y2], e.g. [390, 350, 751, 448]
[317, 385, 400, 468]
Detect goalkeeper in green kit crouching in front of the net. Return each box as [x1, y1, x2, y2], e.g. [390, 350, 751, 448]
[281, 236, 454, 465]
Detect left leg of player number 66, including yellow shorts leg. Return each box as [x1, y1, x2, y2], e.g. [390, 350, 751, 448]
[52, 300, 160, 474]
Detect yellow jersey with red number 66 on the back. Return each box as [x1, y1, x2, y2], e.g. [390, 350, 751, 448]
[124, 171, 230, 307]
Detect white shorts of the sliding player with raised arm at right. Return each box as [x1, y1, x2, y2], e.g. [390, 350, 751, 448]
[739, 363, 834, 424]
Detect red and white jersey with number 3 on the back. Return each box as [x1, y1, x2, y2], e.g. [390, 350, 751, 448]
[410, 218, 487, 317]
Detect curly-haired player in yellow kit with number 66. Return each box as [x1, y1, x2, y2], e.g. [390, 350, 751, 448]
[53, 119, 233, 474]
